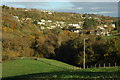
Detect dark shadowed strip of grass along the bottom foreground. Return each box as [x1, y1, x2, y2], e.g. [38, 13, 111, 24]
[2, 71, 120, 80]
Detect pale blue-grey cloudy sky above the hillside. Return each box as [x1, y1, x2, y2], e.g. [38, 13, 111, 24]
[1, 0, 119, 17]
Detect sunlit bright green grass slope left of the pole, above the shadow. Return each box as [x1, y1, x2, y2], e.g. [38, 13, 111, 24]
[2, 58, 80, 78]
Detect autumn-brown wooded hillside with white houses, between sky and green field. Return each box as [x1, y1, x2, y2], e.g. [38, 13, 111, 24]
[0, 5, 120, 67]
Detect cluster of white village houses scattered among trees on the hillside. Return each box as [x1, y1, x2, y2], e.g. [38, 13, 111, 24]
[13, 9, 116, 36]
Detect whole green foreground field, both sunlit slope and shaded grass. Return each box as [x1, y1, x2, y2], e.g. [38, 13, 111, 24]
[2, 58, 120, 80]
